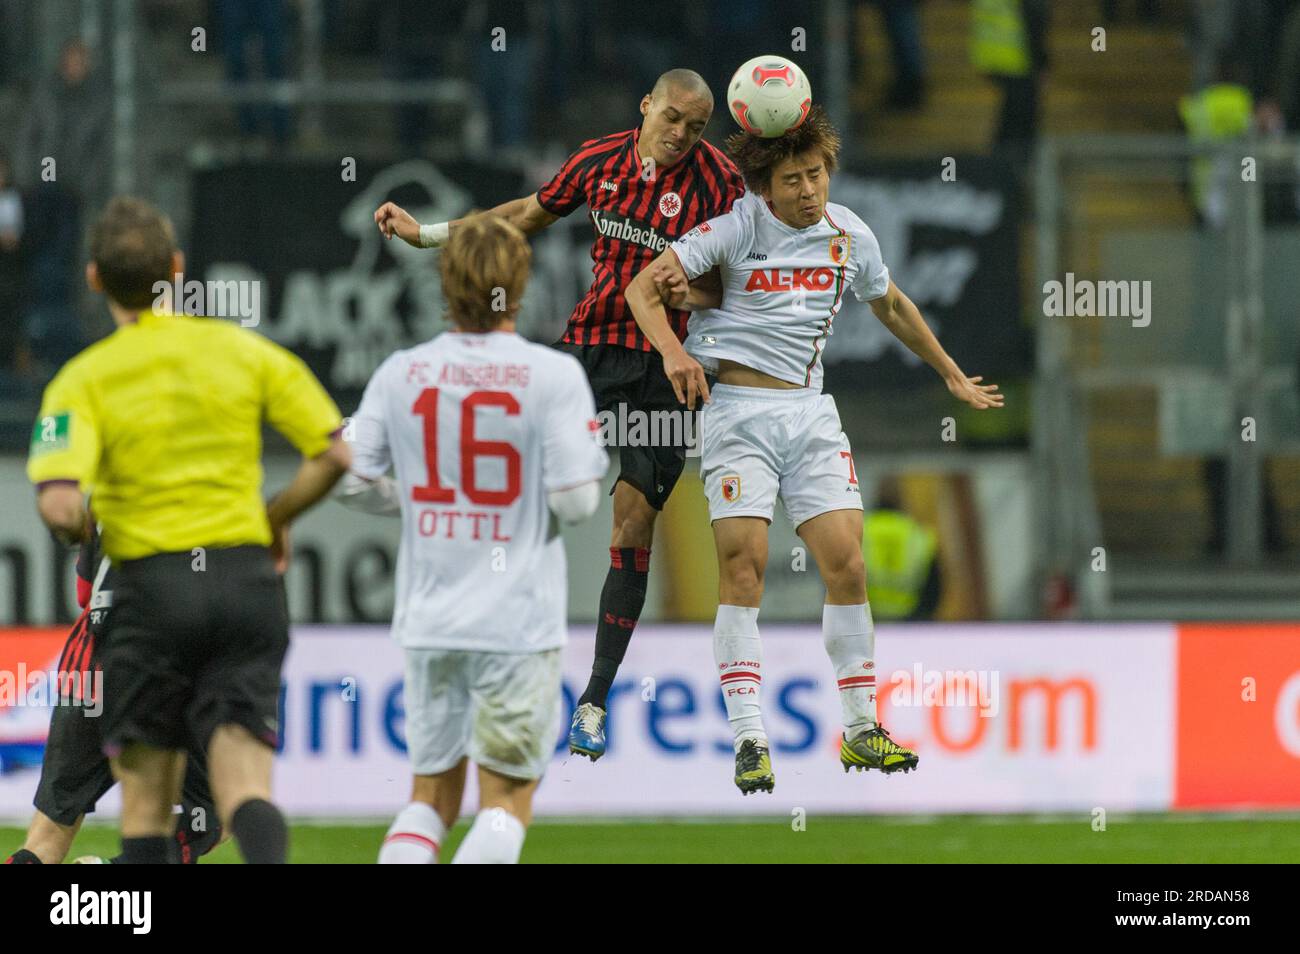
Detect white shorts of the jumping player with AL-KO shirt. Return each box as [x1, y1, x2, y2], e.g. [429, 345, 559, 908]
[699, 385, 862, 528]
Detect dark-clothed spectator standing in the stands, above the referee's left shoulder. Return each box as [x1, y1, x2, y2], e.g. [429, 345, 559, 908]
[20, 40, 112, 370]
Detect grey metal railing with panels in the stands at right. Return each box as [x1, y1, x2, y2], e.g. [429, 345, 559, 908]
[1034, 135, 1300, 615]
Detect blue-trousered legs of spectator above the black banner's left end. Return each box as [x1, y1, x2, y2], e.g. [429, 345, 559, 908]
[213, 0, 291, 146]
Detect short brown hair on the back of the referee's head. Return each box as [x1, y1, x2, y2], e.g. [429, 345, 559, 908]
[90, 195, 176, 309]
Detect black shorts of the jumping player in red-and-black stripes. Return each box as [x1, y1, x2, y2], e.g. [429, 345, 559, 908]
[555, 342, 698, 509]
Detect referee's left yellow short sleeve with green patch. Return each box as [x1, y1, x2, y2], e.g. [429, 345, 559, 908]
[27, 365, 100, 493]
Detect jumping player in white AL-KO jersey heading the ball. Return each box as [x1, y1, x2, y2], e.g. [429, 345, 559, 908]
[627, 108, 1002, 794]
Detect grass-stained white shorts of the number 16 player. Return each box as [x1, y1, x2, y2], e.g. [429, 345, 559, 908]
[406, 649, 560, 779]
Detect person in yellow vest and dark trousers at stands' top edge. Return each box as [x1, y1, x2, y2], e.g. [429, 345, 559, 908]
[971, 0, 1049, 160]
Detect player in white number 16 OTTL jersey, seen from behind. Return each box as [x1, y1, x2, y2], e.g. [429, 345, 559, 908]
[345, 214, 608, 864]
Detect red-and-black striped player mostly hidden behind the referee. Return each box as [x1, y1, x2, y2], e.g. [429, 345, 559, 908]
[4, 525, 222, 864]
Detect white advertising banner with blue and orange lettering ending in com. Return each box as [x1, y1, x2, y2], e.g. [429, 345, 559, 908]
[0, 624, 1177, 818]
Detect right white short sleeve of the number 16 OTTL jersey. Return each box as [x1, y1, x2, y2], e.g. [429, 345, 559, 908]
[542, 355, 610, 491]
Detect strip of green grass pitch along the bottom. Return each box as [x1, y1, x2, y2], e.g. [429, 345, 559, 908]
[0, 815, 1300, 864]
